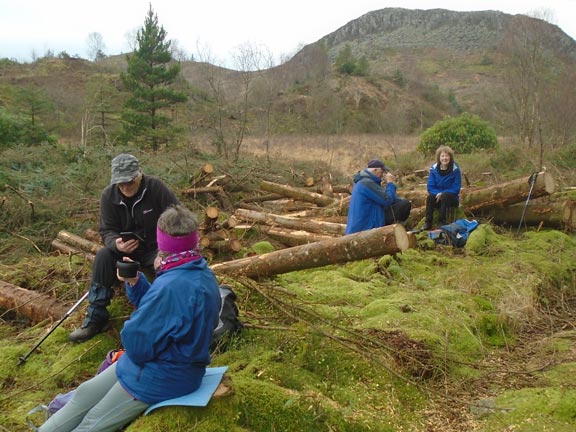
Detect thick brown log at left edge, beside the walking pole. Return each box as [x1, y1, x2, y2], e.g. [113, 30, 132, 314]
[0, 281, 67, 324]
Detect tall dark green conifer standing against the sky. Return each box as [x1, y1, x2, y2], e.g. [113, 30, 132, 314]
[121, 6, 187, 150]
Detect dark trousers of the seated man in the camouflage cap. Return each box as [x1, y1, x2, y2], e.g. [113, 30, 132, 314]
[82, 247, 157, 327]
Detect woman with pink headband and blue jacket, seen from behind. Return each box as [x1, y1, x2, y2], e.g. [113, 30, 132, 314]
[38, 204, 221, 432]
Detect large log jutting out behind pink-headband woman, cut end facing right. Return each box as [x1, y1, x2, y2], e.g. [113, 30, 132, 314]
[212, 224, 410, 279]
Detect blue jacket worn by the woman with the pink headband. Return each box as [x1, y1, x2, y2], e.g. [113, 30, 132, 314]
[116, 258, 220, 404]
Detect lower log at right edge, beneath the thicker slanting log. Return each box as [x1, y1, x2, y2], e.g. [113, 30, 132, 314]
[483, 200, 576, 231]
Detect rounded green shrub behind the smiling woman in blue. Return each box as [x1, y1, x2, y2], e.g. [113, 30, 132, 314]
[417, 113, 498, 154]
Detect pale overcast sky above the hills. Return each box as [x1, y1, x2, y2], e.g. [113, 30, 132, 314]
[0, 0, 576, 66]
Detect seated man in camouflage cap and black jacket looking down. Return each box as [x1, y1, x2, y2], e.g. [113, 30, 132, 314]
[69, 153, 179, 342]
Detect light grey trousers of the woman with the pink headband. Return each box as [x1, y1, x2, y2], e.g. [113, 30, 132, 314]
[38, 363, 148, 432]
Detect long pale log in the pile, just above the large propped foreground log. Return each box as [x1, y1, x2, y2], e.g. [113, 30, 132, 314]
[234, 208, 346, 235]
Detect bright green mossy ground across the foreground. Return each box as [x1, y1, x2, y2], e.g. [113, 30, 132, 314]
[0, 223, 576, 432]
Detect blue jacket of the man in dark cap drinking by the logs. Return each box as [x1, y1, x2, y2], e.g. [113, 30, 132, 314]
[346, 169, 396, 234]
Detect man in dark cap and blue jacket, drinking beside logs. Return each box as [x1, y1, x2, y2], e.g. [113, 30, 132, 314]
[346, 159, 412, 234]
